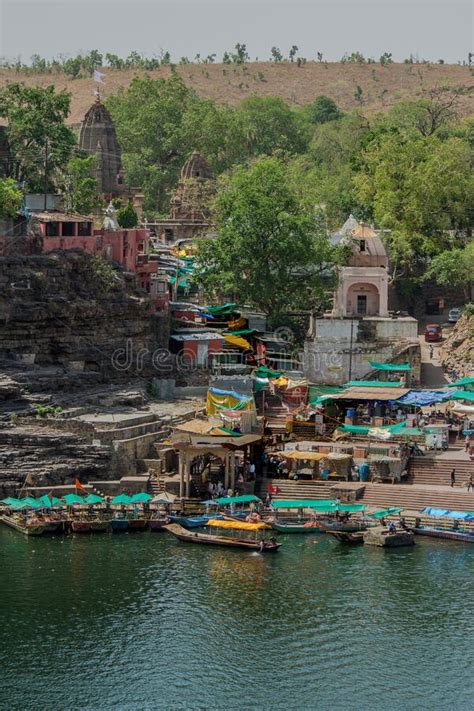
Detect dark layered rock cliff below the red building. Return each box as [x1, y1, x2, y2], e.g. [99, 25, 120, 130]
[0, 251, 156, 372]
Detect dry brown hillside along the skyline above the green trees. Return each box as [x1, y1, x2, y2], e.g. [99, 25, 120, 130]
[0, 62, 474, 124]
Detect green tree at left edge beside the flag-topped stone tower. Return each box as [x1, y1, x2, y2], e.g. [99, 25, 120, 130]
[0, 83, 76, 191]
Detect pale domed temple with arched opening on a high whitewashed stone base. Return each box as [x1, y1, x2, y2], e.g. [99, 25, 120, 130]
[304, 215, 419, 384]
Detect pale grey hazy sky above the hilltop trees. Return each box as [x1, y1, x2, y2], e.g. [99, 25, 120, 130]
[0, 0, 474, 62]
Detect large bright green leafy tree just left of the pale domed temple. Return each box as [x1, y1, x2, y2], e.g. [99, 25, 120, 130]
[198, 158, 335, 326]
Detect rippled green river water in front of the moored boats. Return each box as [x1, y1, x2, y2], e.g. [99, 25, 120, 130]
[0, 529, 474, 711]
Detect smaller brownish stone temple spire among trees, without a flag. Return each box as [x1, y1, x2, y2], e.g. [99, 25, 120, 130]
[148, 151, 215, 244]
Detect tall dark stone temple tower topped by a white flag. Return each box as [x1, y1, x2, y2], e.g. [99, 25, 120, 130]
[79, 97, 125, 197]
